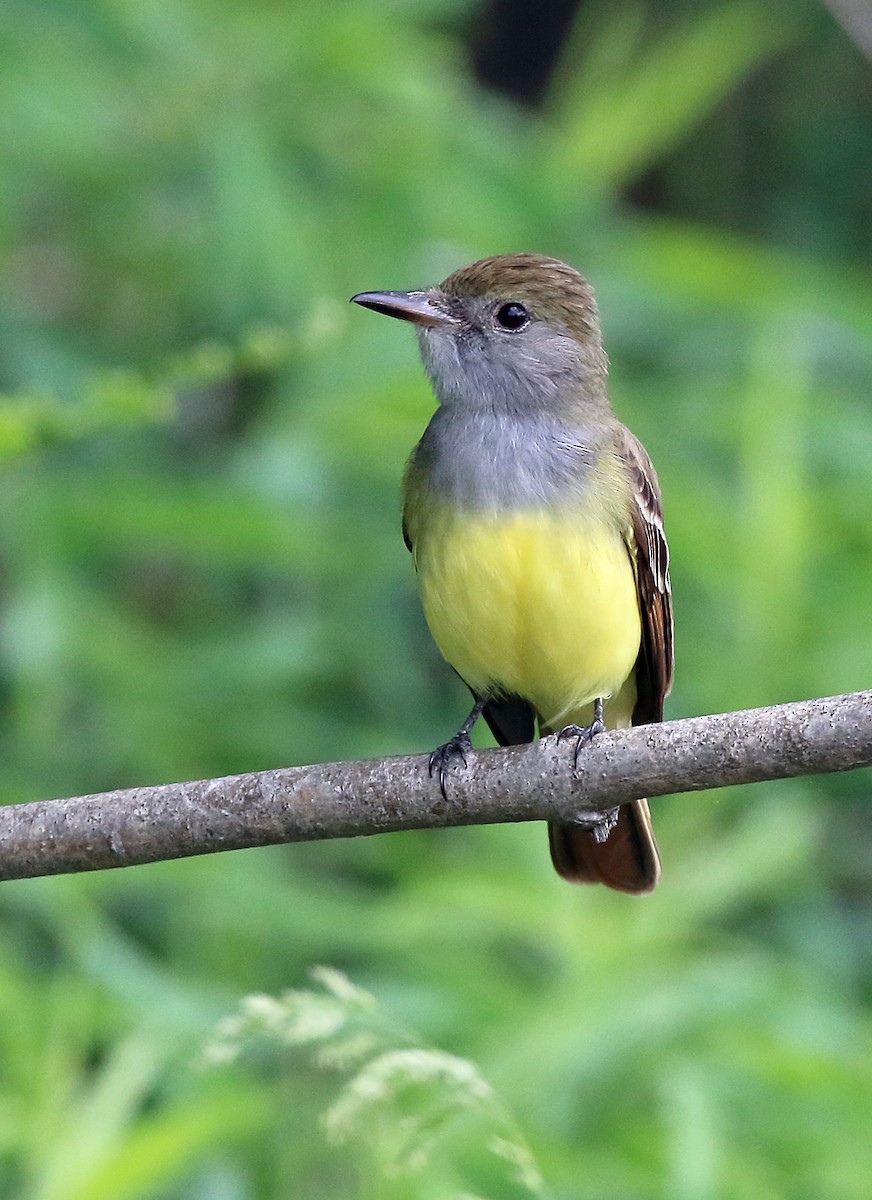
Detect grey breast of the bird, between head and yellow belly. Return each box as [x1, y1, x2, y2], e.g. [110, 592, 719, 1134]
[414, 406, 596, 510]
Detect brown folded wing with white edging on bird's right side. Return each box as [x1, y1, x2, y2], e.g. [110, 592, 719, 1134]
[618, 426, 674, 725]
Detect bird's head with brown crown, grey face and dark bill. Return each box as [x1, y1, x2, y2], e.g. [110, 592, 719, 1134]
[351, 254, 608, 412]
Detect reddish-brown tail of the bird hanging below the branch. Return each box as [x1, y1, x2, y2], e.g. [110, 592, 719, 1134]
[548, 800, 660, 895]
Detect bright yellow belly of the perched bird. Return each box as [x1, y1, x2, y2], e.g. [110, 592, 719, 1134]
[415, 512, 641, 728]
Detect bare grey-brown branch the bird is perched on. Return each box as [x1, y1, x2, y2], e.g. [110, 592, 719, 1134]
[0, 691, 872, 880]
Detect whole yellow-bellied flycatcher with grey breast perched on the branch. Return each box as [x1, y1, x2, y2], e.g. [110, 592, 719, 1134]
[353, 254, 673, 893]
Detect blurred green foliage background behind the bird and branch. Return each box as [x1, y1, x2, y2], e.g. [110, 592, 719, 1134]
[0, 0, 872, 1200]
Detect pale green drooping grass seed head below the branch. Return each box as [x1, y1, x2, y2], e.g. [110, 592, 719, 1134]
[206, 967, 543, 1200]
